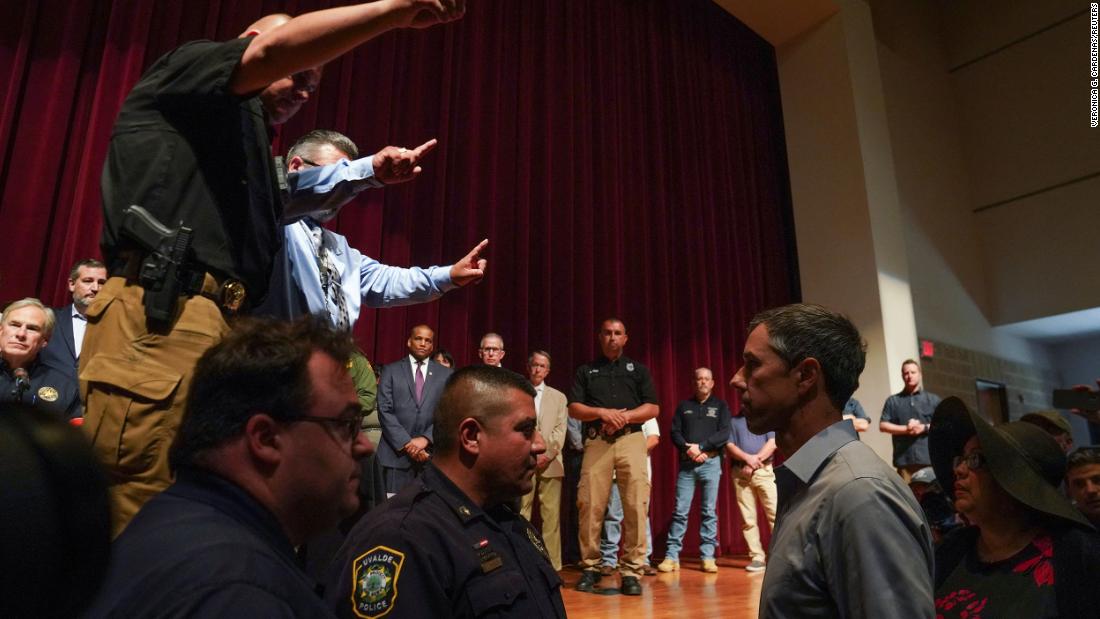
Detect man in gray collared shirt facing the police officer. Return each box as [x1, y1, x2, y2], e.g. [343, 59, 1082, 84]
[732, 305, 935, 619]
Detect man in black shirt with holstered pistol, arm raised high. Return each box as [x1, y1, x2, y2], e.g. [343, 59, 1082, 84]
[79, 0, 465, 533]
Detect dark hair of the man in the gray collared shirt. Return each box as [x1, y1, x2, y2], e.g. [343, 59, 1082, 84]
[749, 303, 867, 410]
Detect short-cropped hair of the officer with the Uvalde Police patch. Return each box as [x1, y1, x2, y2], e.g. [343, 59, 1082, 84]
[432, 365, 535, 454]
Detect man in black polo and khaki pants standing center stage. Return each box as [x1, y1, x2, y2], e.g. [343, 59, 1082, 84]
[569, 318, 660, 595]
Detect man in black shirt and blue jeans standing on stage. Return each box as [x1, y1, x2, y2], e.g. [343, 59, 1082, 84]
[657, 367, 729, 573]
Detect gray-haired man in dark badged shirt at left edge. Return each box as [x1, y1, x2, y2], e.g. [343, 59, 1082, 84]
[0, 298, 80, 419]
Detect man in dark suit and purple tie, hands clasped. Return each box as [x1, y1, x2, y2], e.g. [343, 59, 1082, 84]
[377, 324, 451, 496]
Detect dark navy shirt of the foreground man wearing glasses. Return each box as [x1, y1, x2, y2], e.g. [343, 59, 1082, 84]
[86, 468, 332, 619]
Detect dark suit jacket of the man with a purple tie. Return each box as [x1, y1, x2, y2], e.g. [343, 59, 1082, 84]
[377, 355, 451, 468]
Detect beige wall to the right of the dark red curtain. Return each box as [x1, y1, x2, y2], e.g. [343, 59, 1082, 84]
[718, 0, 1100, 457]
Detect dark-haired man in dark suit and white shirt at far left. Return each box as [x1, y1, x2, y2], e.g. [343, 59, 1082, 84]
[39, 258, 107, 383]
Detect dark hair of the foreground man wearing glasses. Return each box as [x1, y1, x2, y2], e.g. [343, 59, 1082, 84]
[168, 317, 355, 469]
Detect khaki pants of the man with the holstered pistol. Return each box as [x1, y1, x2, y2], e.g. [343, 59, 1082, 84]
[79, 276, 229, 535]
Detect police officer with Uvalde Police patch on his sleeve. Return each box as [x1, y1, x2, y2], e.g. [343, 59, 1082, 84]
[326, 365, 565, 619]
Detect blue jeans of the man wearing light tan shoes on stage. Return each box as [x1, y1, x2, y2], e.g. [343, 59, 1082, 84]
[664, 457, 722, 561]
